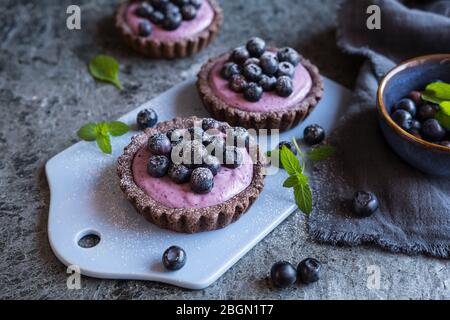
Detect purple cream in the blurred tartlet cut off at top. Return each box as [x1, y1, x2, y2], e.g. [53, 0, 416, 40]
[126, 1, 215, 41]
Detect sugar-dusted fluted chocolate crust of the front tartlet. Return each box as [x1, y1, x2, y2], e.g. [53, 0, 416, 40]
[117, 117, 265, 233]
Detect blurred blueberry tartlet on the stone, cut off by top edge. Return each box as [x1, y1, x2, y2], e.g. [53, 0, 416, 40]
[116, 0, 223, 59]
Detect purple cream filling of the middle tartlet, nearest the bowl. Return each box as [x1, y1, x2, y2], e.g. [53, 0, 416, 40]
[209, 56, 313, 112]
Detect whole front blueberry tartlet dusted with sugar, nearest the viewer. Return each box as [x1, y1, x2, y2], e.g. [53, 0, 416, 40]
[117, 117, 265, 233]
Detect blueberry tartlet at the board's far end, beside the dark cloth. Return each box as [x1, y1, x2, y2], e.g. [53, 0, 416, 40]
[197, 38, 323, 131]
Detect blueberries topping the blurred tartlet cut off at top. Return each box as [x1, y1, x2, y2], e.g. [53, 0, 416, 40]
[135, 0, 203, 37]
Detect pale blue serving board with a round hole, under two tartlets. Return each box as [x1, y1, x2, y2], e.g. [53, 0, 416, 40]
[46, 79, 350, 289]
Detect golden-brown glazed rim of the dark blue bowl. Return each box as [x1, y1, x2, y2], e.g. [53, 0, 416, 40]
[377, 53, 450, 153]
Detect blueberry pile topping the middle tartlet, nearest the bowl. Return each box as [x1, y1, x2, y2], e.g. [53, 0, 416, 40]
[221, 37, 301, 102]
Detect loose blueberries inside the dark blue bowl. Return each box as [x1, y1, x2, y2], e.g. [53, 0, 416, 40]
[391, 91, 450, 147]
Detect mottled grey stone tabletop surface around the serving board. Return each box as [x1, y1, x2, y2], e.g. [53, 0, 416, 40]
[0, 0, 450, 299]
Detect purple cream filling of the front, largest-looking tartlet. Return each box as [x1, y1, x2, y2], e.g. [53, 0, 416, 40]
[132, 147, 253, 209]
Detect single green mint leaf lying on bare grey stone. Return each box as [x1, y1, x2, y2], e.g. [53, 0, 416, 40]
[89, 55, 123, 90]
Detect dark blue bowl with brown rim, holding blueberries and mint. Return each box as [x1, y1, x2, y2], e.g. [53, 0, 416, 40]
[377, 54, 450, 177]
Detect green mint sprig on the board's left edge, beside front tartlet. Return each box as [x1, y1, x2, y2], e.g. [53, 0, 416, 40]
[77, 121, 130, 154]
